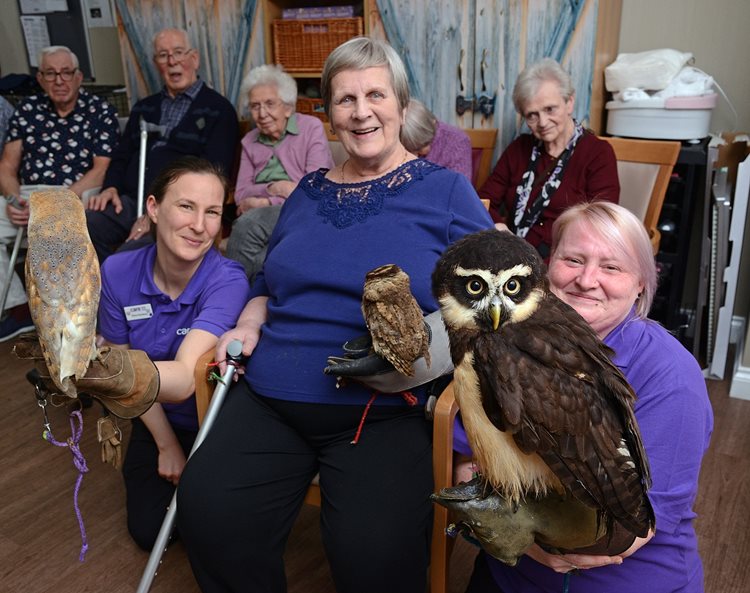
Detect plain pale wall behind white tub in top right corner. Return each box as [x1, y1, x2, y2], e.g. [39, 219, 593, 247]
[616, 0, 750, 132]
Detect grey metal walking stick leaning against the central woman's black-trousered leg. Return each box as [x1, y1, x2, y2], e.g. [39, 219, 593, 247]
[136, 340, 242, 593]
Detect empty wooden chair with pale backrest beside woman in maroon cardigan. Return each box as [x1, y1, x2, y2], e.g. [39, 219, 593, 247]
[602, 137, 681, 255]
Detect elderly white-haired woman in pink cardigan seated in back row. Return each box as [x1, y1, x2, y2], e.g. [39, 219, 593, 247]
[227, 65, 333, 281]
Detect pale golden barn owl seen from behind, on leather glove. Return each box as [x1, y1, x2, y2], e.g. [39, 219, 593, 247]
[26, 189, 101, 397]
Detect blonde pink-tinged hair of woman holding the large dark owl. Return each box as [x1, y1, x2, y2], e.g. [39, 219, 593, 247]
[550, 202, 658, 319]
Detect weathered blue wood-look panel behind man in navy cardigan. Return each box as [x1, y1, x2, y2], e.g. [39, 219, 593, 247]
[115, 0, 257, 105]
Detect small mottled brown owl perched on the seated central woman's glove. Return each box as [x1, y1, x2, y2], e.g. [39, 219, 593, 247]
[362, 264, 430, 376]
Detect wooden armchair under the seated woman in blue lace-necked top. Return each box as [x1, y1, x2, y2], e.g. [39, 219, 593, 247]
[194, 350, 458, 593]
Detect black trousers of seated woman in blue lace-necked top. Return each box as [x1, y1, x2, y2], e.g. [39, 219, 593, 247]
[177, 381, 433, 593]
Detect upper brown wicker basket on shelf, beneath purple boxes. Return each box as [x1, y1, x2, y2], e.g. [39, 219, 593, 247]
[272, 17, 363, 72]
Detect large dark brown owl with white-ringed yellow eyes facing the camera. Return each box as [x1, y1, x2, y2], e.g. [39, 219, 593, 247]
[432, 230, 654, 551]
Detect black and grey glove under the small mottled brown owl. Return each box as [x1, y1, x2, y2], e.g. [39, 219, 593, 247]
[323, 311, 453, 393]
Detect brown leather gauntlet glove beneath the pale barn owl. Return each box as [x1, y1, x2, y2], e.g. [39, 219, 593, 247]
[13, 336, 159, 419]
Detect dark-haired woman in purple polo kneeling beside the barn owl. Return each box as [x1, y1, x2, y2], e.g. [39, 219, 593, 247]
[99, 157, 249, 550]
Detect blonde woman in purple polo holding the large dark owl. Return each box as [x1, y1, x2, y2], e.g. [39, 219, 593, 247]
[454, 202, 713, 593]
